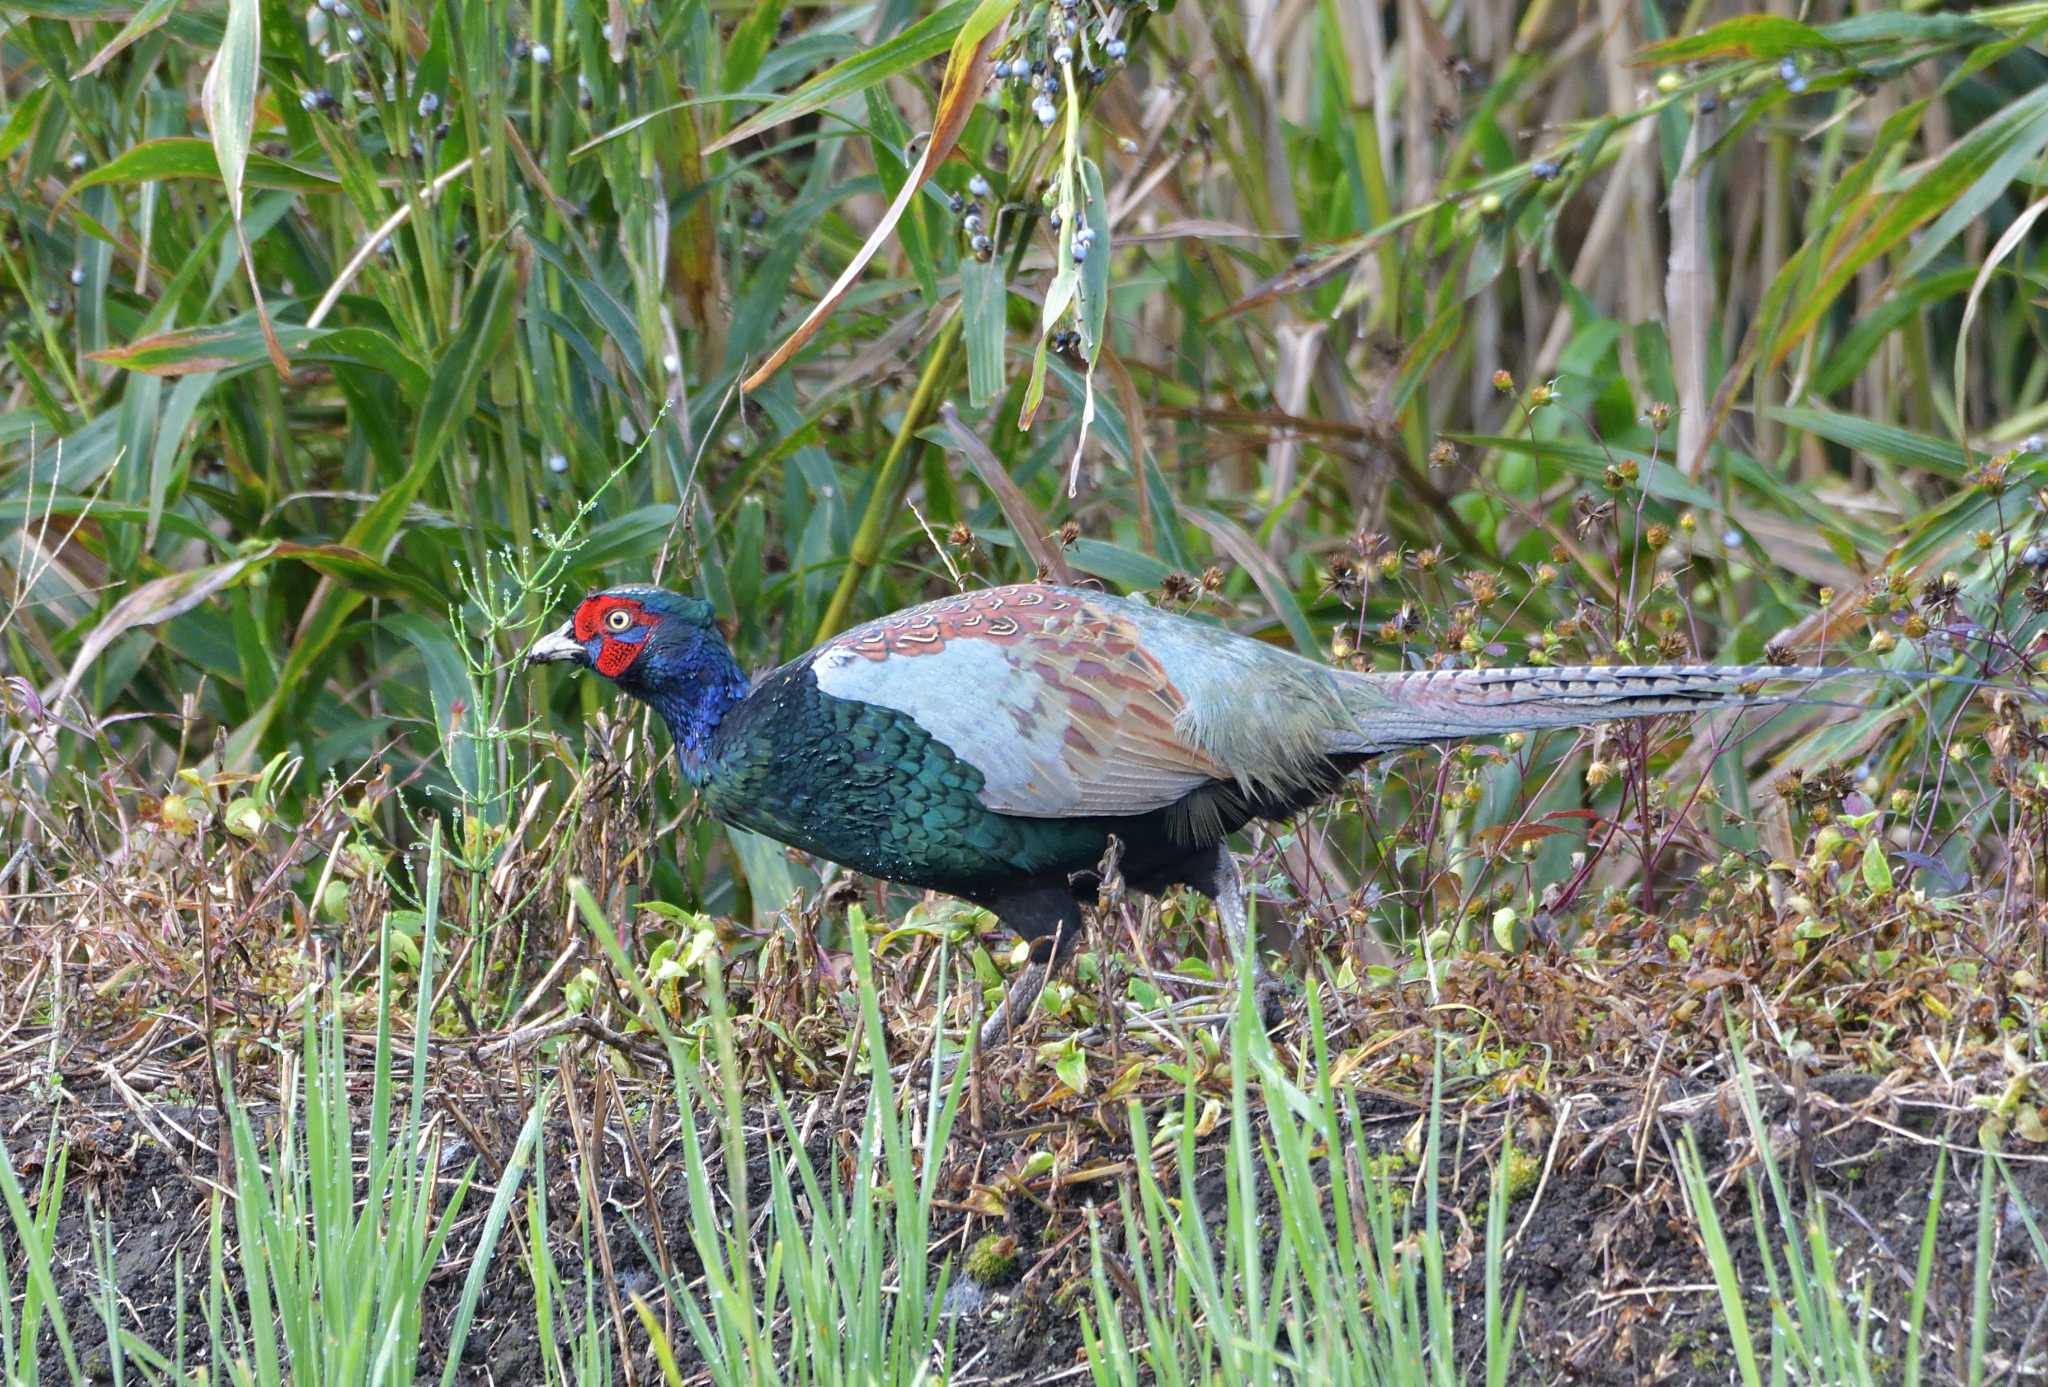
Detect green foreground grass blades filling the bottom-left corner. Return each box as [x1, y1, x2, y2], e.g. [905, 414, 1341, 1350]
[0, 840, 545, 1387]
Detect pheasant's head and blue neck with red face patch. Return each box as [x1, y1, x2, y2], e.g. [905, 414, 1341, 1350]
[526, 586, 748, 770]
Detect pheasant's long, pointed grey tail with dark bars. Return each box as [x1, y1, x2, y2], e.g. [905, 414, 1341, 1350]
[1341, 664, 1892, 752]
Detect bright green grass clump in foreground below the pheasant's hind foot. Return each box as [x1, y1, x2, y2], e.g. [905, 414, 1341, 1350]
[1083, 979, 1522, 1387]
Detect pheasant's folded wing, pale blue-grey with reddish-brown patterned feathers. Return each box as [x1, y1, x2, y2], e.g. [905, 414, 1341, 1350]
[811, 584, 1233, 817]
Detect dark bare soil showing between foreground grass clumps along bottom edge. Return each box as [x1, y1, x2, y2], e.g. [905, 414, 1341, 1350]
[16, 1076, 2048, 1385]
